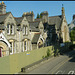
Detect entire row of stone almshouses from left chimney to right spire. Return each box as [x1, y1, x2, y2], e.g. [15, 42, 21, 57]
[0, 2, 70, 57]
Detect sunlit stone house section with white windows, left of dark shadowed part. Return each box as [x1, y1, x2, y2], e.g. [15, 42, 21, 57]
[0, 2, 44, 57]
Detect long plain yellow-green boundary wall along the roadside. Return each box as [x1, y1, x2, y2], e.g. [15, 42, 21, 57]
[0, 46, 53, 74]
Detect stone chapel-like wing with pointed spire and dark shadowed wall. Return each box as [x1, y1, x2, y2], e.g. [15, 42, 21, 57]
[35, 6, 70, 46]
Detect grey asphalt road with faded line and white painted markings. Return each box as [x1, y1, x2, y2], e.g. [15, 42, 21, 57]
[19, 50, 75, 74]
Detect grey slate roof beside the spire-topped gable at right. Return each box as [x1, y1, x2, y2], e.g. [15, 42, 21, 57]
[48, 15, 62, 29]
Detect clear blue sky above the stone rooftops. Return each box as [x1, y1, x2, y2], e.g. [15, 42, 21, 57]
[0, 1, 75, 24]
